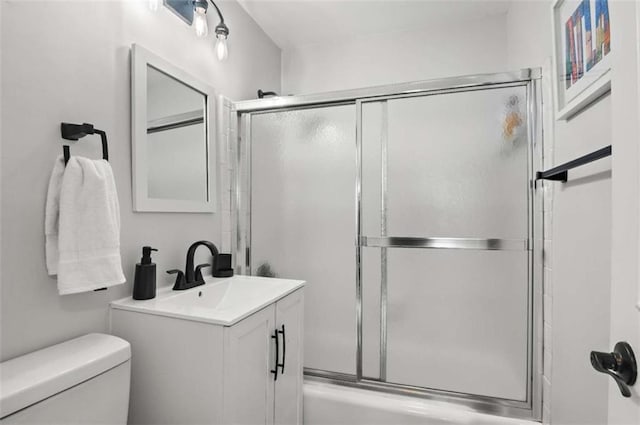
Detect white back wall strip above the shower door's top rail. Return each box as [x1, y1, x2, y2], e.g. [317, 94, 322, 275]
[282, 14, 507, 94]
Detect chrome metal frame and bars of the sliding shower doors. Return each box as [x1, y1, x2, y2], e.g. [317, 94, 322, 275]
[232, 69, 543, 420]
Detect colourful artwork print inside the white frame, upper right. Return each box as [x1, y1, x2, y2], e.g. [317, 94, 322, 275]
[565, 0, 611, 89]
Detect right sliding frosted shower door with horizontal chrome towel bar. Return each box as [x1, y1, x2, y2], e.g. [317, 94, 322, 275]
[360, 87, 530, 400]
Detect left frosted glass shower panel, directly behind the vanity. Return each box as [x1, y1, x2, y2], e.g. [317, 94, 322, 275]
[251, 105, 356, 374]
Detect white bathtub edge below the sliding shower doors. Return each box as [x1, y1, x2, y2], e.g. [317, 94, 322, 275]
[304, 380, 540, 425]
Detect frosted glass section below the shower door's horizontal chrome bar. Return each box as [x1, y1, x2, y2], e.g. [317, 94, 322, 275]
[387, 248, 528, 400]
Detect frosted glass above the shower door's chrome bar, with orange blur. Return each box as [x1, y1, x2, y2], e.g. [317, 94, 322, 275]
[363, 87, 528, 239]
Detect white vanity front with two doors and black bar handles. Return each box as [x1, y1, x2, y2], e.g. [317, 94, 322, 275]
[223, 290, 304, 425]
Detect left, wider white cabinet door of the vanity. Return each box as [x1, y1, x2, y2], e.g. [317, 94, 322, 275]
[224, 304, 276, 425]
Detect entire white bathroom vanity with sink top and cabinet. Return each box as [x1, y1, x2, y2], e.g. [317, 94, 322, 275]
[110, 276, 304, 424]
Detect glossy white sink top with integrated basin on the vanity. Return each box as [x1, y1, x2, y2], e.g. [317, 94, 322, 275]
[111, 276, 304, 326]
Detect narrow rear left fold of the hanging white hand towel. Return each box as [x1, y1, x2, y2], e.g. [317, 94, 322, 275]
[44, 155, 64, 276]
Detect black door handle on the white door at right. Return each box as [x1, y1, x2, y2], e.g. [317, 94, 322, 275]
[591, 341, 638, 397]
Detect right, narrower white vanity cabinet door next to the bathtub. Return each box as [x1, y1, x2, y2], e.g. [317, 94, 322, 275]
[275, 289, 304, 425]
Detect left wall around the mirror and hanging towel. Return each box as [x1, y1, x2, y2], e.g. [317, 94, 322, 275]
[0, 0, 280, 360]
